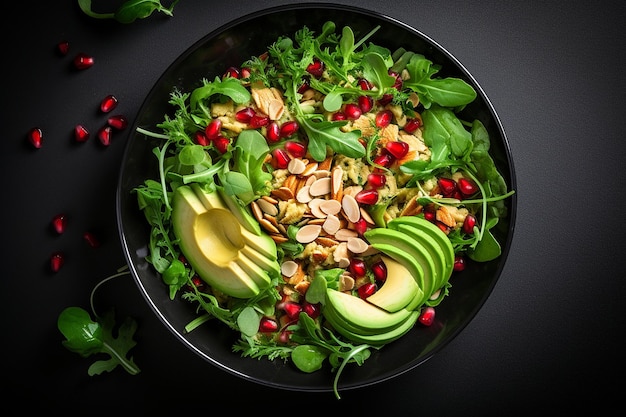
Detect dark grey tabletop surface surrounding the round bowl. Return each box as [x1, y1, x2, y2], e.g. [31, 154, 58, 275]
[0, 0, 626, 416]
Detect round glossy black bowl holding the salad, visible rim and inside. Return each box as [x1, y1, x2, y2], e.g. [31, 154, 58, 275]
[117, 4, 516, 392]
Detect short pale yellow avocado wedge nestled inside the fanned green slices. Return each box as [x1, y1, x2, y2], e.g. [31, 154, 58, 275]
[366, 256, 424, 313]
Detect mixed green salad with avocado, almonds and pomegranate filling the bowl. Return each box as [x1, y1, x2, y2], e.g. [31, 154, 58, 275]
[133, 21, 513, 393]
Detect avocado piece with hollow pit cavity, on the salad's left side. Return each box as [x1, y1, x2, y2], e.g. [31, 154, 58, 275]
[172, 185, 270, 298]
